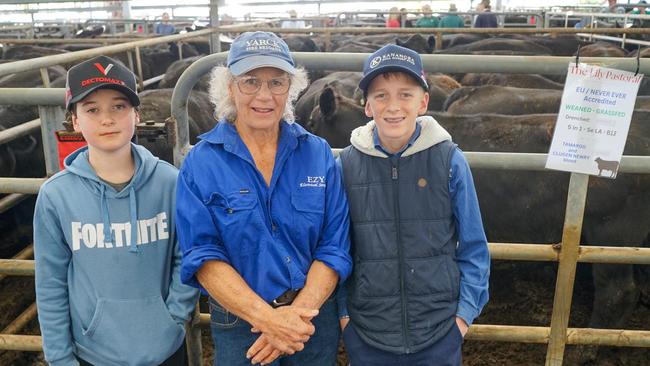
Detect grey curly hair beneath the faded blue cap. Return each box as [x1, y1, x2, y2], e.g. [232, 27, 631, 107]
[209, 66, 309, 123]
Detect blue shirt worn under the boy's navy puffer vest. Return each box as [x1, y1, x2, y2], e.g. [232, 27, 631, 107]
[337, 123, 490, 325]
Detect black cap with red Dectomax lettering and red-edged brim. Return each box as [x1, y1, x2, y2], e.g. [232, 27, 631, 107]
[65, 56, 140, 110]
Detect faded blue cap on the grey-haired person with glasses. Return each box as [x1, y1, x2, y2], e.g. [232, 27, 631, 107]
[228, 32, 296, 76]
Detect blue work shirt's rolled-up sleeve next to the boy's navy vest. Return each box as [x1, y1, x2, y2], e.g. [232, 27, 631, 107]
[314, 146, 352, 283]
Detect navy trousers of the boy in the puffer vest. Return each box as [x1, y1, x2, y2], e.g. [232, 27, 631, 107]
[343, 323, 463, 366]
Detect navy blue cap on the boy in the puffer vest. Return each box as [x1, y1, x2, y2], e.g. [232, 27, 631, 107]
[359, 44, 429, 93]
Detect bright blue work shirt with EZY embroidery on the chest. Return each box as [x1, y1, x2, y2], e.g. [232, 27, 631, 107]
[176, 122, 352, 302]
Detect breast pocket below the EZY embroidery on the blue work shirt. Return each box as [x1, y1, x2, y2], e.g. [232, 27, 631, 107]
[291, 191, 325, 244]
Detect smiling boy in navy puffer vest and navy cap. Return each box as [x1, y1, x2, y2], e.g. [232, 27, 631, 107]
[340, 45, 490, 366]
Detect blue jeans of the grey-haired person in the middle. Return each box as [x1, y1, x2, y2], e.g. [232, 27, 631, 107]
[210, 297, 341, 366]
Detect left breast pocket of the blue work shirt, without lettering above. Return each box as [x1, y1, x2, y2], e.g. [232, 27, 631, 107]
[206, 191, 265, 254]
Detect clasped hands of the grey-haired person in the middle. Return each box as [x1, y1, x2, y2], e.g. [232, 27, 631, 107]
[246, 305, 318, 365]
